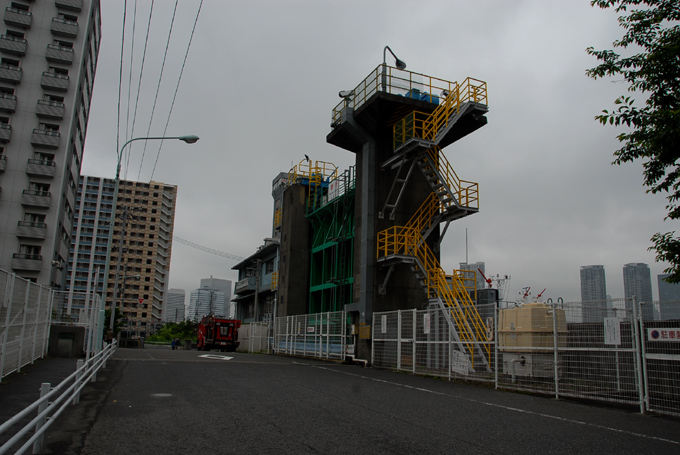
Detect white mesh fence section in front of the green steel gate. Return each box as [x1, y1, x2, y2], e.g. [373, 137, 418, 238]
[273, 311, 351, 359]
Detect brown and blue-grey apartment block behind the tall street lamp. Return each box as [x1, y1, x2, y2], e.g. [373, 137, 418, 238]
[67, 176, 177, 337]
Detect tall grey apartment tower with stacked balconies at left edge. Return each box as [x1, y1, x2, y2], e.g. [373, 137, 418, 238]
[0, 0, 101, 288]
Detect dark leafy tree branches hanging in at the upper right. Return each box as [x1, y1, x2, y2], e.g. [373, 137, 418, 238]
[586, 0, 680, 283]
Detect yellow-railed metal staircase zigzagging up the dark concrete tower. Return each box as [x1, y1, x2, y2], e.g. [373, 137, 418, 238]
[377, 78, 491, 369]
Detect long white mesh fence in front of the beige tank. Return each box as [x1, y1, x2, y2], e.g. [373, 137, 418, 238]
[371, 300, 680, 416]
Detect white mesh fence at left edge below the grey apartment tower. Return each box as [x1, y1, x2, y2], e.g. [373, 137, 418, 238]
[0, 270, 52, 379]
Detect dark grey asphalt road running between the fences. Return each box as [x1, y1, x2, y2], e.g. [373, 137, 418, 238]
[45, 347, 680, 455]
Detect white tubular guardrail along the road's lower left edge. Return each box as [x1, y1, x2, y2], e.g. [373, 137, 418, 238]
[0, 340, 116, 454]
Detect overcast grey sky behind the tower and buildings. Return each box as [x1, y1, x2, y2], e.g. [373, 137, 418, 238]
[83, 0, 675, 301]
